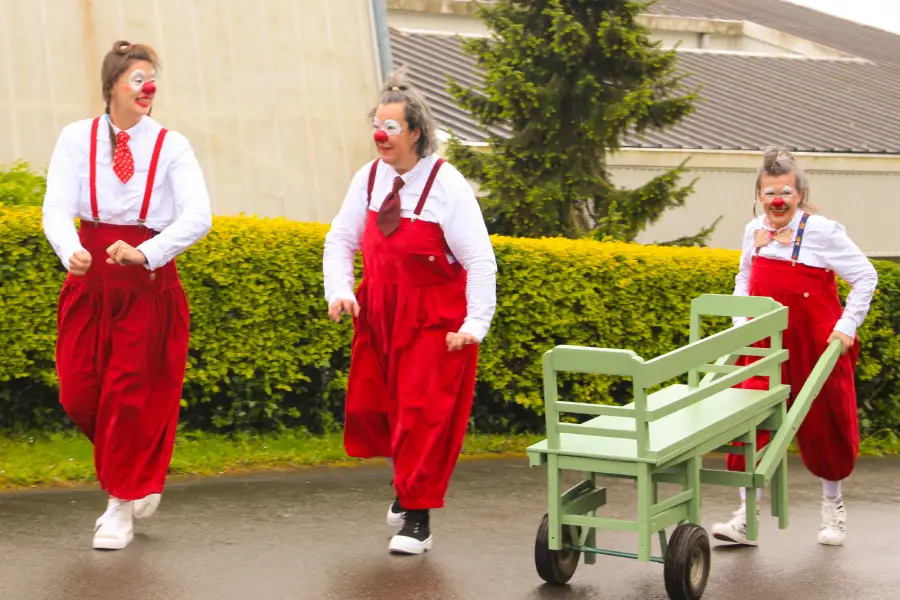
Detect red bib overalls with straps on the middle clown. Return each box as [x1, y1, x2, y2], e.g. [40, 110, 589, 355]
[344, 161, 478, 510]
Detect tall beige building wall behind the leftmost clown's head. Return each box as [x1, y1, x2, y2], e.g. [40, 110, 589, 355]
[0, 0, 380, 221]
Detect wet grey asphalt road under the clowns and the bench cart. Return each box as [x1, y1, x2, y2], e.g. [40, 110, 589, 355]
[0, 459, 900, 600]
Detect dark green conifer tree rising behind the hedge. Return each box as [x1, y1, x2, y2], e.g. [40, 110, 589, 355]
[448, 0, 715, 245]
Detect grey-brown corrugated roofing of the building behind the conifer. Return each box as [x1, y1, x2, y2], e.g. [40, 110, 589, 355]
[391, 0, 900, 154]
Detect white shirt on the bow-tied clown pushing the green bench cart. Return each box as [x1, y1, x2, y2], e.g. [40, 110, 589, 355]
[734, 210, 878, 338]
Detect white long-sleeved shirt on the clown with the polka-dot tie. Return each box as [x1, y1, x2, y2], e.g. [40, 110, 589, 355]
[43, 117, 212, 270]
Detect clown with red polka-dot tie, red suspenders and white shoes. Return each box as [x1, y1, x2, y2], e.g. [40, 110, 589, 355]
[43, 42, 212, 550]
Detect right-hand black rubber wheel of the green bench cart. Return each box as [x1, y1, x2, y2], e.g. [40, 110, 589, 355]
[663, 523, 710, 600]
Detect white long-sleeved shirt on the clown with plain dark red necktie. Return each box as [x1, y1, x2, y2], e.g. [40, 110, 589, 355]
[322, 155, 497, 342]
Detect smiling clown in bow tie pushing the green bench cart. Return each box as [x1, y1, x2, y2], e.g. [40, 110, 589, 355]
[712, 148, 878, 546]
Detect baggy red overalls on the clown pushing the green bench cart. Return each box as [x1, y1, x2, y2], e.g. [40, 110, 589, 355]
[727, 256, 859, 481]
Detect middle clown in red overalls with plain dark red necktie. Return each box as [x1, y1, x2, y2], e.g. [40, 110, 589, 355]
[323, 74, 497, 554]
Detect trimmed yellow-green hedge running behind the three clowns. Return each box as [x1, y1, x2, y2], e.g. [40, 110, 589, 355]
[0, 208, 900, 434]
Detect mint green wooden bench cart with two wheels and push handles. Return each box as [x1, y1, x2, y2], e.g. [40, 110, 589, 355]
[527, 295, 840, 600]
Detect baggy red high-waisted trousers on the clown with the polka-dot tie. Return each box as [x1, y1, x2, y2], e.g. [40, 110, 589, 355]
[56, 222, 190, 501]
